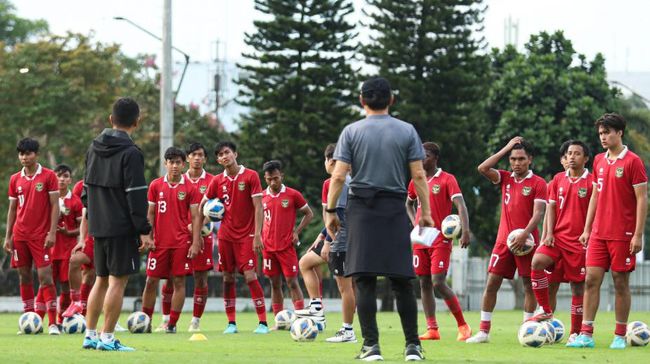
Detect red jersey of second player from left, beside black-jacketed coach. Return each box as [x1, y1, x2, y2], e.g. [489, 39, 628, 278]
[52, 191, 83, 260]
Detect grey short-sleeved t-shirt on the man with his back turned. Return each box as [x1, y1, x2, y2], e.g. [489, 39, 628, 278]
[334, 115, 425, 193]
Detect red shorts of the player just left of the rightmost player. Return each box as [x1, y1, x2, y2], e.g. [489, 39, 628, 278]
[535, 241, 586, 282]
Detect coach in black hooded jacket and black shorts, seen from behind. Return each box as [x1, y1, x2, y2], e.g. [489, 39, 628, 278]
[82, 98, 152, 351]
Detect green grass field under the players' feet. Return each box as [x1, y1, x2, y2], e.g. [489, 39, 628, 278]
[0, 311, 650, 364]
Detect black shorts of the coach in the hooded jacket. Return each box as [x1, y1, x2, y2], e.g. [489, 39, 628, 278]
[95, 236, 140, 277]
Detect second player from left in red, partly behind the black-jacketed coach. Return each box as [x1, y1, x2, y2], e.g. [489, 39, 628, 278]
[52, 164, 83, 323]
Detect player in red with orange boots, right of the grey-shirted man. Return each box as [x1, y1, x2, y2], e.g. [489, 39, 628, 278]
[406, 142, 472, 341]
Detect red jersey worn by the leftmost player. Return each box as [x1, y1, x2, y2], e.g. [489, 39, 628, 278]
[8, 164, 59, 241]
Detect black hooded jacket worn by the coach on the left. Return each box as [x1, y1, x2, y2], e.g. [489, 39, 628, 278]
[82, 129, 151, 238]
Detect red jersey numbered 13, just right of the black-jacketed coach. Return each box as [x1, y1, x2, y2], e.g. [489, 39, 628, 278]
[147, 175, 201, 248]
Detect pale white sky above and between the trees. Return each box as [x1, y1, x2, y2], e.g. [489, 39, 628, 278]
[13, 0, 650, 129]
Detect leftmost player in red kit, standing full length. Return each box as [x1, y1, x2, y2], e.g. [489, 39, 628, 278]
[4, 138, 60, 335]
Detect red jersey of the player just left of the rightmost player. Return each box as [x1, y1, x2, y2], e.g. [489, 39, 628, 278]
[548, 169, 594, 252]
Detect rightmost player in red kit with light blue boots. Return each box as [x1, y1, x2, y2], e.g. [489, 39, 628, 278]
[567, 114, 648, 349]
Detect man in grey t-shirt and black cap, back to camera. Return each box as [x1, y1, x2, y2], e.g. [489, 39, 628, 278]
[325, 77, 433, 361]
